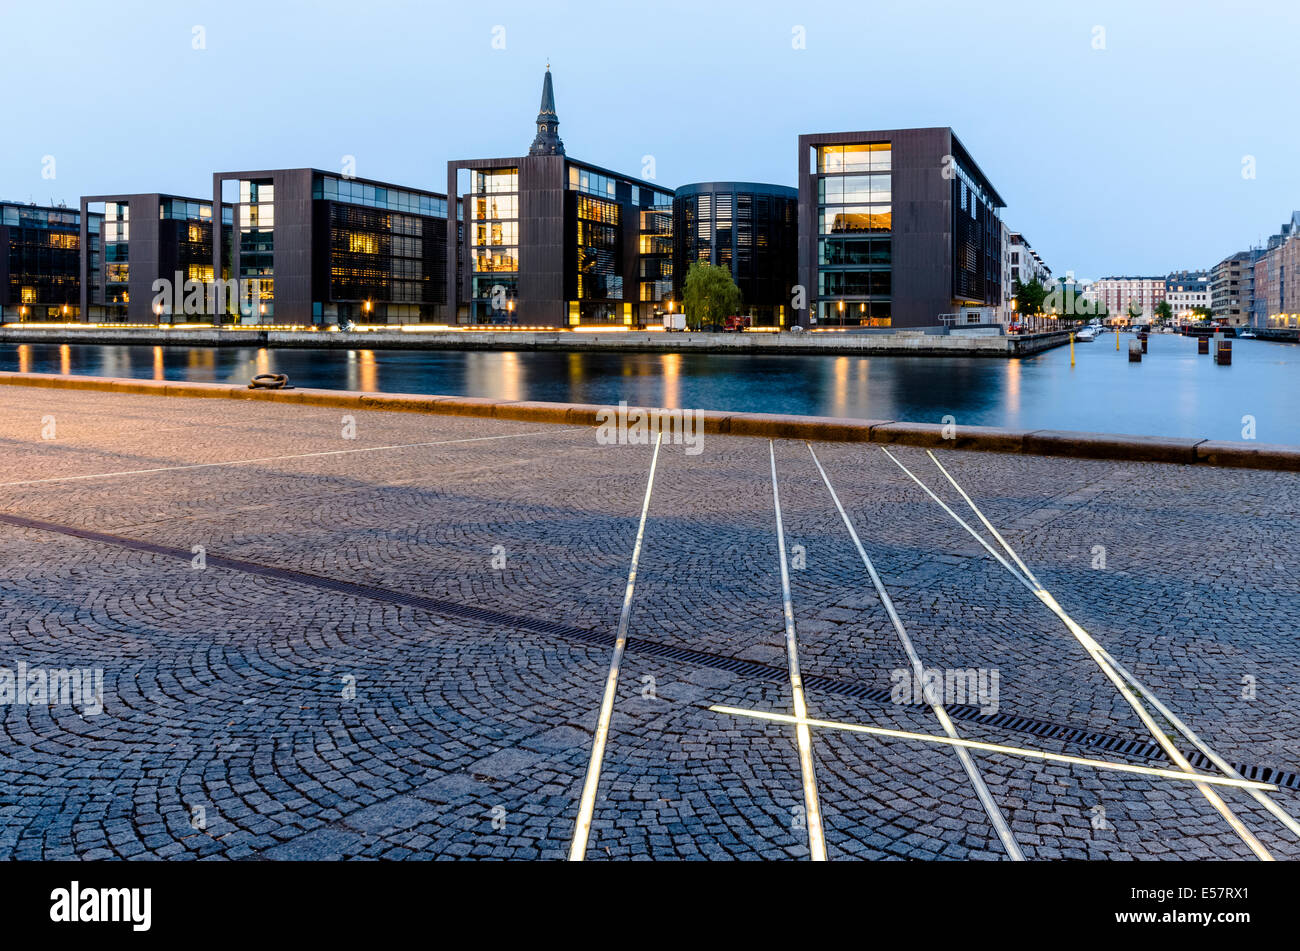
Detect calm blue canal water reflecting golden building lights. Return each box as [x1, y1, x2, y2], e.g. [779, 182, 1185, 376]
[0, 334, 1300, 444]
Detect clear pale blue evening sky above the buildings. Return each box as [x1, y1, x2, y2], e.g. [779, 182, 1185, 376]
[0, 0, 1300, 277]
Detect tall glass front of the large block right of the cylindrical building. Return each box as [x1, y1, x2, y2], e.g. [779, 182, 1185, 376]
[813, 142, 893, 326]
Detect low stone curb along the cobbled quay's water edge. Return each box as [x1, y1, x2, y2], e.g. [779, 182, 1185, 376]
[0, 372, 1300, 472]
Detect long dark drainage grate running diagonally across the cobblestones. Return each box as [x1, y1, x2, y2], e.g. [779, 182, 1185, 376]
[0, 513, 1300, 790]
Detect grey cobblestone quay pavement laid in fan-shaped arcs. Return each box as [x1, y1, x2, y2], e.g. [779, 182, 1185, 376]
[0, 387, 1300, 860]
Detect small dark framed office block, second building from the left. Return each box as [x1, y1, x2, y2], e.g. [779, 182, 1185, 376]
[79, 192, 229, 323]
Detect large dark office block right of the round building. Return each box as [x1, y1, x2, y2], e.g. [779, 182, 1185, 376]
[798, 127, 1005, 327]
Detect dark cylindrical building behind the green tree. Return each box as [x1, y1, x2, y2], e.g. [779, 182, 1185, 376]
[671, 182, 800, 327]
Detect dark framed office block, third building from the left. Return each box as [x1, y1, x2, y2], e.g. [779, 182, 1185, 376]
[211, 169, 458, 326]
